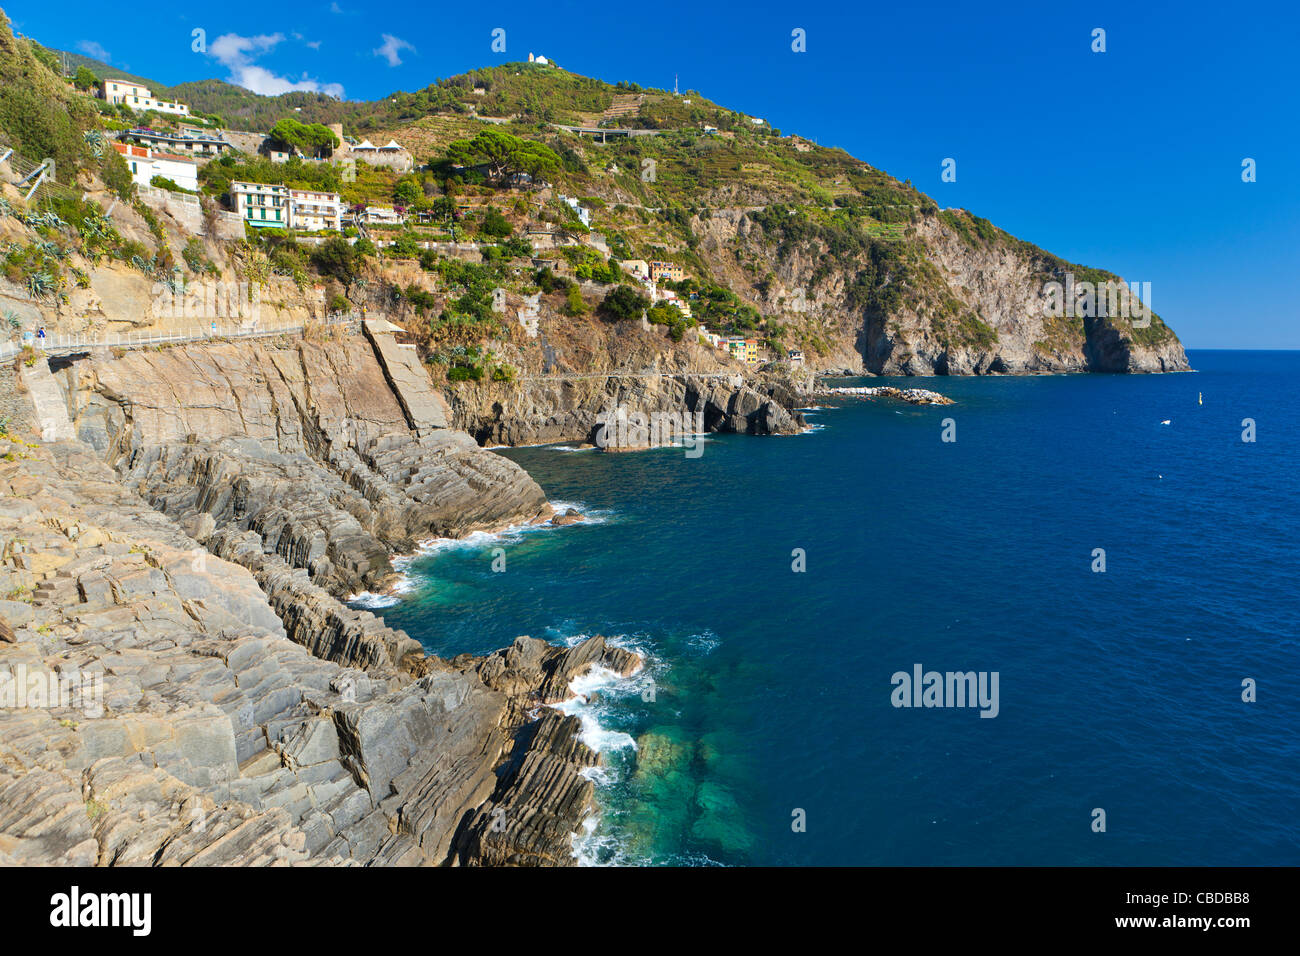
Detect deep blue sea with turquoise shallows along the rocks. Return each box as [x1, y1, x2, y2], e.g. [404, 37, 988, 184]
[364, 351, 1300, 865]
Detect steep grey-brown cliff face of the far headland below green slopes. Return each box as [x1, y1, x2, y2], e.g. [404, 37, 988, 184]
[692, 207, 1190, 376]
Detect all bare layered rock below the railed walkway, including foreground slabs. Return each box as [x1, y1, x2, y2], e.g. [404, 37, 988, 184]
[0, 329, 640, 865]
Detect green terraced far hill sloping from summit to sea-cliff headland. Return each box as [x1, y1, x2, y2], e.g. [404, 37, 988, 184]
[358, 64, 1187, 375]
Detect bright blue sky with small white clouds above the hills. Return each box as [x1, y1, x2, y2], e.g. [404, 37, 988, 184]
[0, 0, 1300, 349]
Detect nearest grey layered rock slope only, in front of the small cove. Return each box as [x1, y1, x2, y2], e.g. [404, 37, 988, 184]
[0, 431, 641, 865]
